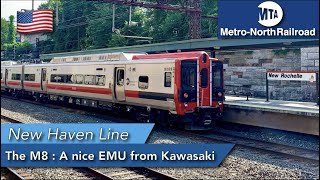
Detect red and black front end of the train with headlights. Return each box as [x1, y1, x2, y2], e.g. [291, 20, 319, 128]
[175, 53, 224, 130]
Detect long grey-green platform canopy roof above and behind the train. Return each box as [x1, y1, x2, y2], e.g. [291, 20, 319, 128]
[40, 38, 319, 59]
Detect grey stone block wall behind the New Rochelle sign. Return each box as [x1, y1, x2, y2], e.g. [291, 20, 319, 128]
[216, 47, 319, 101]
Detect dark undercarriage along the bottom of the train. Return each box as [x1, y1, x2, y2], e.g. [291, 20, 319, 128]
[2, 89, 222, 130]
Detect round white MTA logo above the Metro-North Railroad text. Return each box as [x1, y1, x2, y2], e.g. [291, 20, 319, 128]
[258, 1, 283, 27]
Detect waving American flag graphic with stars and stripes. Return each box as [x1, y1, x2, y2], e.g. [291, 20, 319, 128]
[17, 10, 53, 34]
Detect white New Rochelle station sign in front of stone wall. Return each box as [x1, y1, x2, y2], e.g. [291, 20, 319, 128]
[267, 71, 316, 82]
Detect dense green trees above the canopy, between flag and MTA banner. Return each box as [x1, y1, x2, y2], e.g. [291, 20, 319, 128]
[35, 0, 218, 53]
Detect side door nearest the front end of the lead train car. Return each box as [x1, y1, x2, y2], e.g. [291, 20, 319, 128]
[114, 66, 126, 101]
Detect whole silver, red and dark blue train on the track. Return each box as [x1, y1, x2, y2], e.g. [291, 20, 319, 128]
[1, 51, 224, 130]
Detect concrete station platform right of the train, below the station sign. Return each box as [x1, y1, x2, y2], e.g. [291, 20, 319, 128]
[223, 96, 319, 136]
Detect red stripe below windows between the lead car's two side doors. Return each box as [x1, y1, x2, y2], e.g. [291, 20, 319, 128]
[47, 84, 111, 94]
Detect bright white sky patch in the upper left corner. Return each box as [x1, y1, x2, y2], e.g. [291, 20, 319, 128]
[1, 0, 47, 20]
